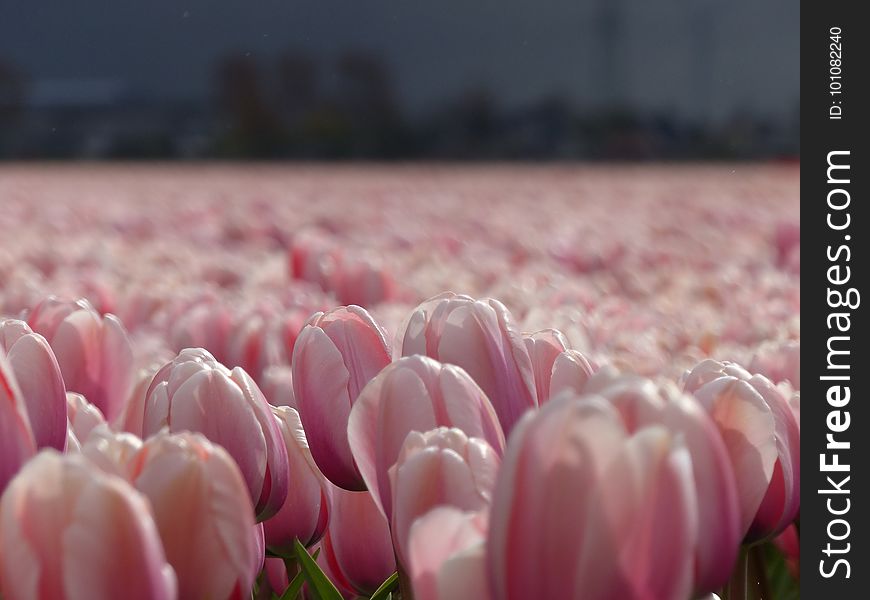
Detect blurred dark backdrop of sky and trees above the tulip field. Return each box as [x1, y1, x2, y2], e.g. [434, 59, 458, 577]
[0, 0, 799, 160]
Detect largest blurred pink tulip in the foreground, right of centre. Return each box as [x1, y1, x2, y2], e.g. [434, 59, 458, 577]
[487, 394, 699, 600]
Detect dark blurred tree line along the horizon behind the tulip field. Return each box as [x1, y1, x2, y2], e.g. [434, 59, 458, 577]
[0, 51, 799, 160]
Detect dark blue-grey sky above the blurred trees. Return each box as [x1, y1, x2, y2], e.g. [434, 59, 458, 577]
[0, 0, 799, 117]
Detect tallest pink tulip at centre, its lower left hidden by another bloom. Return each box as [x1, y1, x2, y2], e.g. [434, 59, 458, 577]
[401, 292, 538, 434]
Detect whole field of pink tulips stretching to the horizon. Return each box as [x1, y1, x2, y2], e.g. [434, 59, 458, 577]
[0, 164, 800, 600]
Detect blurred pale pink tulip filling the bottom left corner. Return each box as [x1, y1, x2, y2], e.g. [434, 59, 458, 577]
[0, 450, 176, 600]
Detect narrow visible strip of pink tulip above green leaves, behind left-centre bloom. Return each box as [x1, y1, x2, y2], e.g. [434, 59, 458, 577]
[264, 406, 332, 556]
